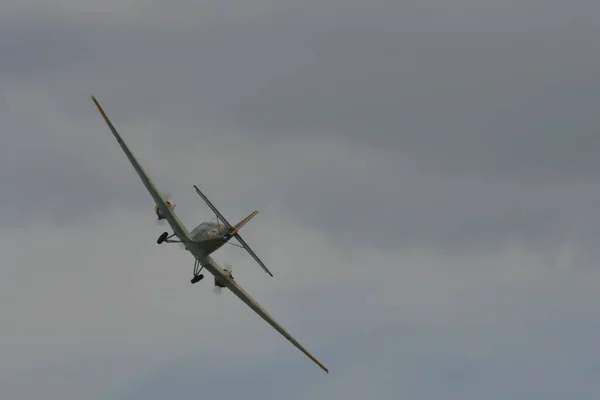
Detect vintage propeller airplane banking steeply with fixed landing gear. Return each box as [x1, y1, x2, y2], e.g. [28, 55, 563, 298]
[91, 96, 329, 373]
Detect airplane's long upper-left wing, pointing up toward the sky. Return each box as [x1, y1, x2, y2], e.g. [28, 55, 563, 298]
[92, 96, 189, 241]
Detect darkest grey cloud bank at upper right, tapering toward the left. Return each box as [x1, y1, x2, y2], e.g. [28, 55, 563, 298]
[223, 28, 600, 177]
